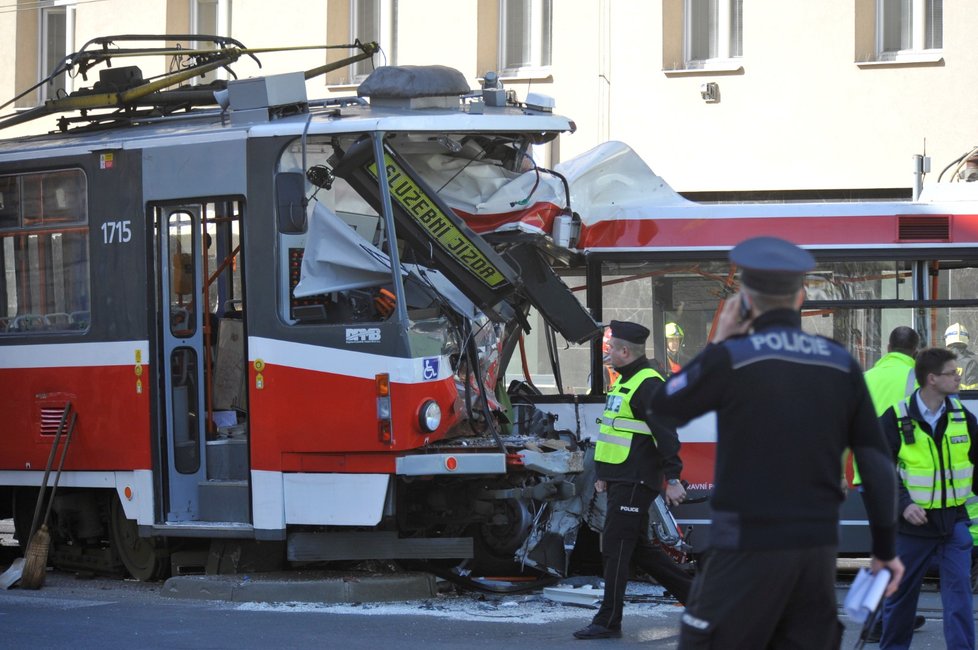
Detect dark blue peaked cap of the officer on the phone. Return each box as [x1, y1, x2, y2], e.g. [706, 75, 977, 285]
[730, 237, 815, 296]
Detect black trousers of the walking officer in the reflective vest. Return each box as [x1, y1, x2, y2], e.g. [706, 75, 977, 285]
[593, 482, 693, 629]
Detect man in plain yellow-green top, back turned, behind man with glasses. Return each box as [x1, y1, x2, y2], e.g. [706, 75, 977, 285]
[852, 325, 926, 643]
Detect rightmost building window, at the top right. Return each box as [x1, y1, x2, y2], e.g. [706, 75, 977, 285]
[876, 0, 944, 61]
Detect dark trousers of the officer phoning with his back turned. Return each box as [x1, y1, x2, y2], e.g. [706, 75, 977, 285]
[679, 545, 843, 650]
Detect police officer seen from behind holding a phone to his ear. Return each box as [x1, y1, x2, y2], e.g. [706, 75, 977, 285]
[652, 237, 903, 649]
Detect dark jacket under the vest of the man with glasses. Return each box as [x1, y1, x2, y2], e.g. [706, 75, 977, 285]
[880, 392, 978, 537]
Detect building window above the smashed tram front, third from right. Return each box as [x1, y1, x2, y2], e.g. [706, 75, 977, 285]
[499, 0, 553, 76]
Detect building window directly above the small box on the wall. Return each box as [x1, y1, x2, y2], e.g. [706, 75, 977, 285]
[684, 0, 744, 68]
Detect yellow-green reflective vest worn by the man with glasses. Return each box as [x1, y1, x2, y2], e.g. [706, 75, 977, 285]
[897, 397, 974, 509]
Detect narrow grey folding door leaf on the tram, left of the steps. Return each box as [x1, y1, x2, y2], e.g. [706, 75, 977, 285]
[156, 204, 207, 522]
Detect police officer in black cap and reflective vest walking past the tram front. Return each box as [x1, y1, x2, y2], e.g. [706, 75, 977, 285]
[574, 320, 692, 639]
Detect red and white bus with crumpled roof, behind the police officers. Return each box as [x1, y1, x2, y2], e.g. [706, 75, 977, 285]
[509, 143, 978, 552]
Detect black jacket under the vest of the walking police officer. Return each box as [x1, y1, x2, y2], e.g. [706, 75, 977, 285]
[594, 356, 683, 492]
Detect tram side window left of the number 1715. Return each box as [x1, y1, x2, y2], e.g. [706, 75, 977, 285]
[0, 169, 91, 335]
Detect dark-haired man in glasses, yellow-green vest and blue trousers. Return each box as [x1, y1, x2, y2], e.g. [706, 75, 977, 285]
[880, 348, 978, 650]
